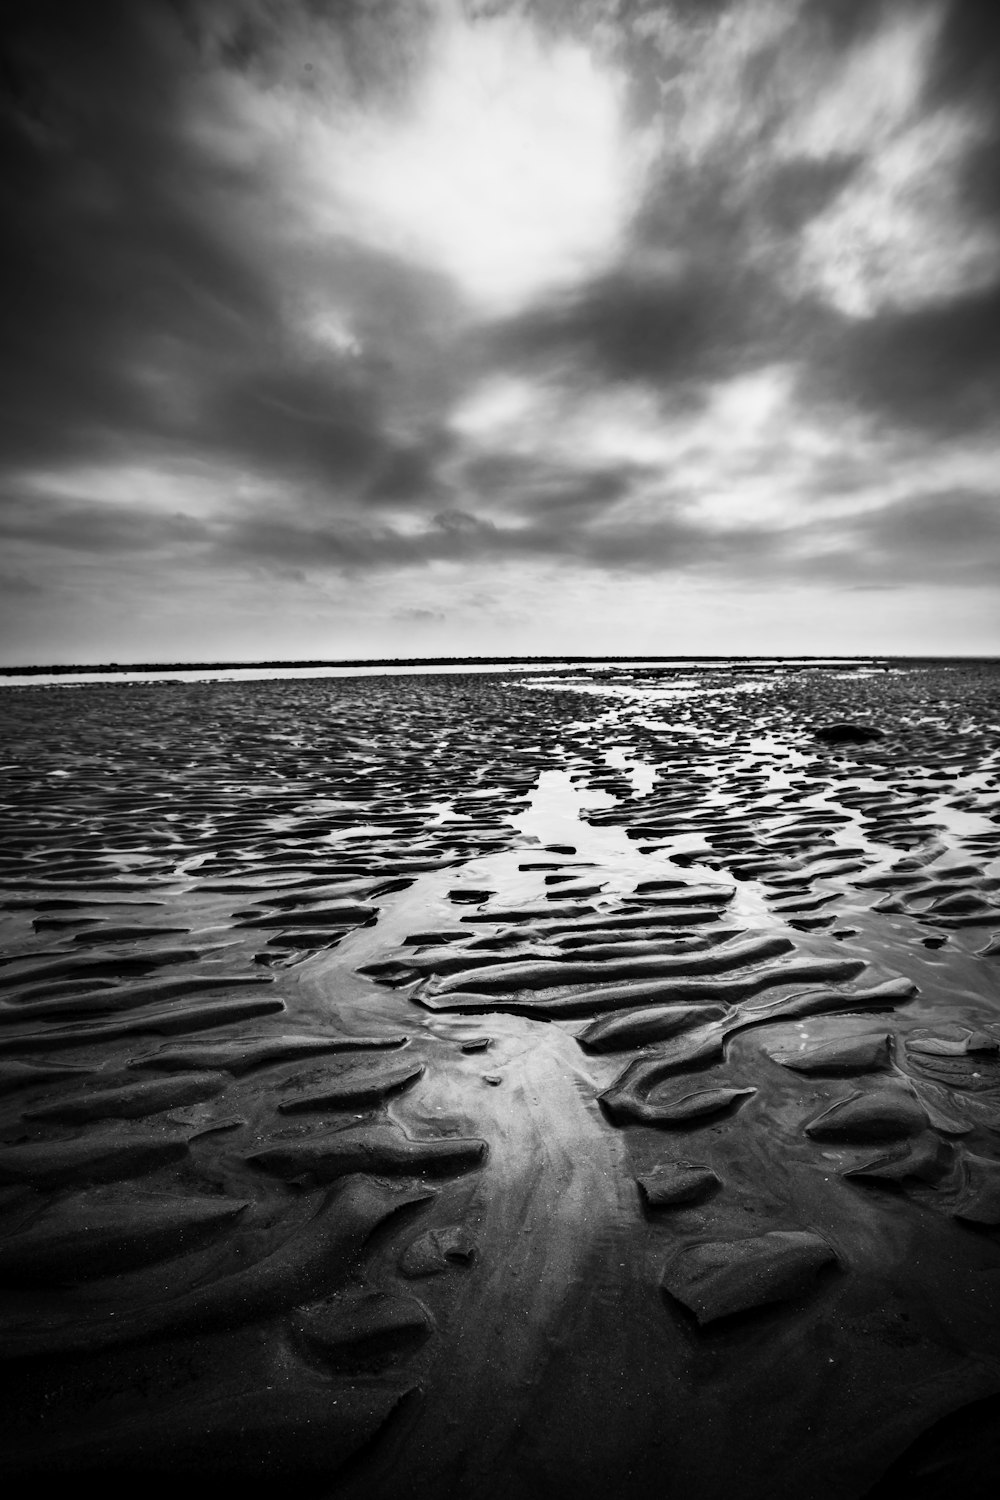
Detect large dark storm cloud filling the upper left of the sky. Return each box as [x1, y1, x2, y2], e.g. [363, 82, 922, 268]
[0, 0, 449, 497]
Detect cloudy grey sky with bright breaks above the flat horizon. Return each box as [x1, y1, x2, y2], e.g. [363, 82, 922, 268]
[0, 0, 1000, 665]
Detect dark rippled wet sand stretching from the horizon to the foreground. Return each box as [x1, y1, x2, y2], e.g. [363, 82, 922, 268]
[0, 663, 1000, 1500]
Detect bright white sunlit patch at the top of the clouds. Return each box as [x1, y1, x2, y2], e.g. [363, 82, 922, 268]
[304, 6, 646, 312]
